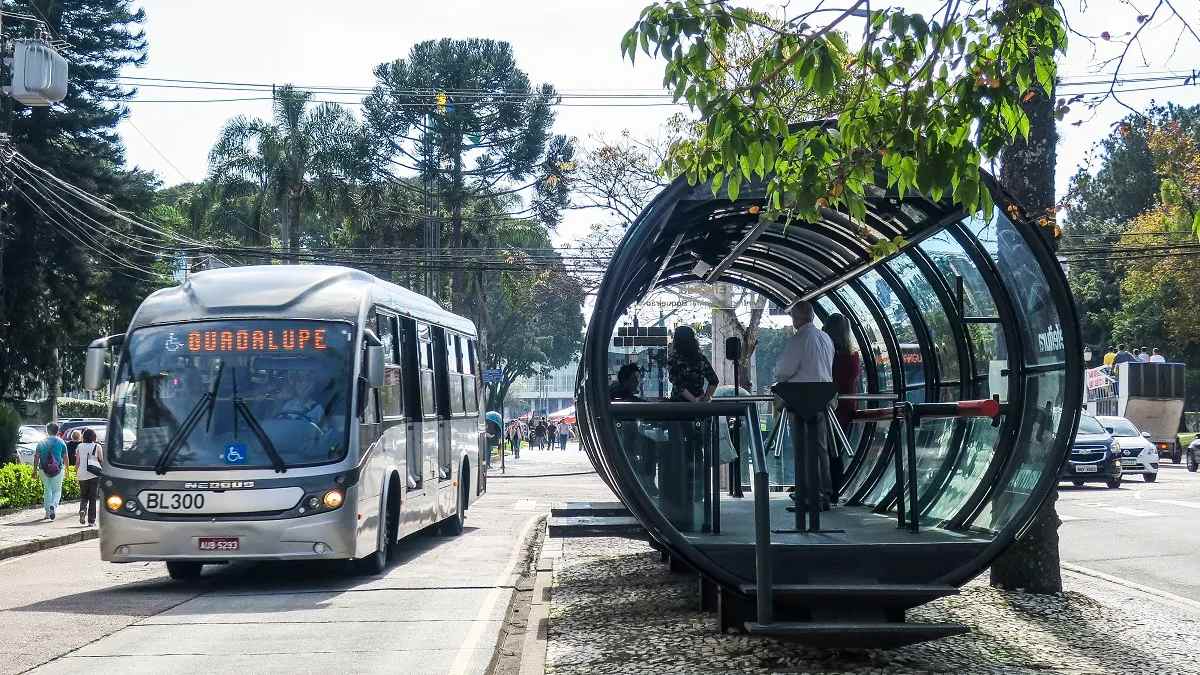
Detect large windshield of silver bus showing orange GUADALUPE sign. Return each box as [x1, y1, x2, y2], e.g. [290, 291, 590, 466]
[109, 319, 354, 472]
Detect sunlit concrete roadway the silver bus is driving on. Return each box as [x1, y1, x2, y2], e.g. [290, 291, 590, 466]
[0, 450, 612, 675]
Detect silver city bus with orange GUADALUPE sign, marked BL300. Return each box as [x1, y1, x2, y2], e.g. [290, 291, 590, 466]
[84, 265, 487, 579]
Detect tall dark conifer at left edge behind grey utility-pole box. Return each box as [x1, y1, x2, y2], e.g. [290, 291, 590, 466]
[0, 0, 154, 398]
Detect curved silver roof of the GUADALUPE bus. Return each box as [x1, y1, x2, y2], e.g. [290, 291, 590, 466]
[130, 265, 475, 336]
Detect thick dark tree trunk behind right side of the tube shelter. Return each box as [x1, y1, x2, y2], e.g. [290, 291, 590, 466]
[991, 0, 1062, 593]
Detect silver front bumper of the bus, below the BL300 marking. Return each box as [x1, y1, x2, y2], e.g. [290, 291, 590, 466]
[100, 506, 358, 562]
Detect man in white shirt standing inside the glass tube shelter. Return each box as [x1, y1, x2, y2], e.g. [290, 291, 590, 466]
[775, 300, 833, 510]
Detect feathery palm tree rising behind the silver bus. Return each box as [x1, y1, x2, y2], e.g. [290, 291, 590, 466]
[209, 84, 365, 261]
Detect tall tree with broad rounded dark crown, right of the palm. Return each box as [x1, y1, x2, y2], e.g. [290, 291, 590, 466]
[364, 38, 575, 311]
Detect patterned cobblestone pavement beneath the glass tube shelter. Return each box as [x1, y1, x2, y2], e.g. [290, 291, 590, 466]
[546, 538, 1200, 675]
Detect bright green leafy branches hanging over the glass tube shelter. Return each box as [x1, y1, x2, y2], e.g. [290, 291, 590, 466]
[622, 1, 1067, 219]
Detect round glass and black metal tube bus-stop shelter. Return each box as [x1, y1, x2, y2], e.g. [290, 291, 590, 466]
[577, 170, 1082, 644]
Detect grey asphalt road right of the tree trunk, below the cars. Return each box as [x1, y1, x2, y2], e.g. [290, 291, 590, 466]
[1058, 461, 1200, 601]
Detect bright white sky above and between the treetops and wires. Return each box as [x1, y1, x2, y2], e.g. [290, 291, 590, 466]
[120, 0, 1200, 248]
